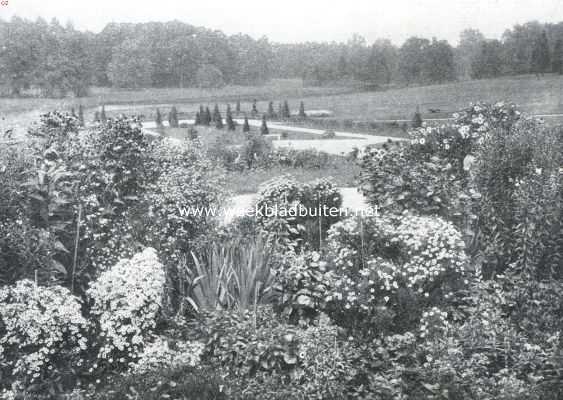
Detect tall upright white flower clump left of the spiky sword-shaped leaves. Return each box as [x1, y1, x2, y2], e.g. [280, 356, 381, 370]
[88, 248, 166, 364]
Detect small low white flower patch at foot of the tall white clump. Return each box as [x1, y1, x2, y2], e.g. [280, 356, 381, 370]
[130, 336, 205, 373]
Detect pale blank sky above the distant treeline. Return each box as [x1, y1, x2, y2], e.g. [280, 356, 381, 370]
[0, 0, 563, 44]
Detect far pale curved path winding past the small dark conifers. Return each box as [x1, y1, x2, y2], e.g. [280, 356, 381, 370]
[143, 119, 405, 155]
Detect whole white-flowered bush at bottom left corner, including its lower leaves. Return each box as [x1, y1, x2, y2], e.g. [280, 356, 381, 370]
[0, 280, 89, 393]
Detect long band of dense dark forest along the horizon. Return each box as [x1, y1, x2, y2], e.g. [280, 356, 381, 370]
[0, 17, 563, 97]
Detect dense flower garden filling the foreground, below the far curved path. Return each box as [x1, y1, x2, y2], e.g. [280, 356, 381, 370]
[0, 103, 563, 400]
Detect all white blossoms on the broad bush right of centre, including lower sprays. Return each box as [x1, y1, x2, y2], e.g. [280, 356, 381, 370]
[328, 214, 467, 309]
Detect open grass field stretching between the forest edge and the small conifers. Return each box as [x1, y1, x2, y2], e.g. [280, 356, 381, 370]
[4, 74, 563, 138]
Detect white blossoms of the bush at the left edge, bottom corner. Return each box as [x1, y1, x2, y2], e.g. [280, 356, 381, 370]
[0, 280, 88, 381]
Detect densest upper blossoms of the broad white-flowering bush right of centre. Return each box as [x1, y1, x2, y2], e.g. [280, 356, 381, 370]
[327, 214, 467, 292]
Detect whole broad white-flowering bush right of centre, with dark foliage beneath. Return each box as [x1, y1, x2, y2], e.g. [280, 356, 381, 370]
[320, 214, 468, 330]
